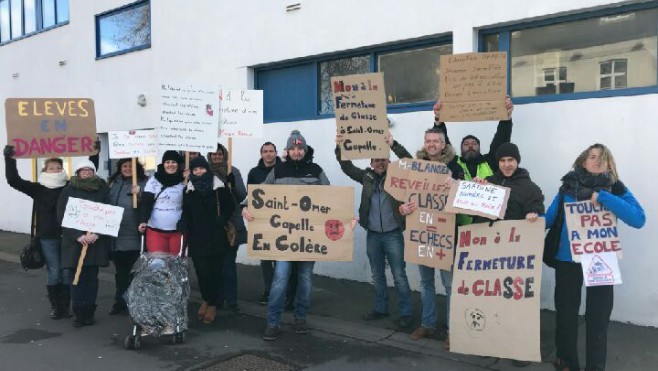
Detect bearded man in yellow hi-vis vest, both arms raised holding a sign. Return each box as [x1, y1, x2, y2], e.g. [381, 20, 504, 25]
[434, 96, 514, 180]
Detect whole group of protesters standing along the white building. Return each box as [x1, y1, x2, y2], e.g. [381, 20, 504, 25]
[4, 98, 645, 370]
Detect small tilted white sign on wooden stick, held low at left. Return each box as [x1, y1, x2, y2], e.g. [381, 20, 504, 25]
[62, 197, 123, 237]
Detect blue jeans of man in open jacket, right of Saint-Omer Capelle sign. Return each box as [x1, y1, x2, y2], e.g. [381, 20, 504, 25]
[366, 229, 411, 316]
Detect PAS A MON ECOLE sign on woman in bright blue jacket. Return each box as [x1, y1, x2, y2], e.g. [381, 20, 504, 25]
[564, 201, 622, 269]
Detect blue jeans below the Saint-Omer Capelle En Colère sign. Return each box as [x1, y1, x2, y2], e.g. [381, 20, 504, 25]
[267, 261, 315, 326]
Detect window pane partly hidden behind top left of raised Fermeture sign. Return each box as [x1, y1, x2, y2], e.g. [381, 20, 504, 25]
[318, 55, 370, 115]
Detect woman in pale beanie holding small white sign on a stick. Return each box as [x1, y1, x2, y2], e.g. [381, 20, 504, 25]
[57, 160, 110, 327]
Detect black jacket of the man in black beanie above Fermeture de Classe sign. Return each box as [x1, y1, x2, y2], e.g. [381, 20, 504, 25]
[487, 168, 544, 220]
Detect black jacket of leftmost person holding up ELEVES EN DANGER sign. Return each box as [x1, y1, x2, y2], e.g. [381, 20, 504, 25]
[5, 157, 64, 239]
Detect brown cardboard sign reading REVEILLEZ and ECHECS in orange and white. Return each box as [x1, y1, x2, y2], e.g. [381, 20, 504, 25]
[384, 158, 455, 271]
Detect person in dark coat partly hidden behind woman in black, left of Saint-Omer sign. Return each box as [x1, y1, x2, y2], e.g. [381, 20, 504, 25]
[208, 143, 247, 311]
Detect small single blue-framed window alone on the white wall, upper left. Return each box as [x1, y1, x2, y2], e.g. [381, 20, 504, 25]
[96, 1, 151, 58]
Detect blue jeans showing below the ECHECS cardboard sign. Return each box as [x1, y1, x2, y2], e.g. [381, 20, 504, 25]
[418, 265, 452, 328]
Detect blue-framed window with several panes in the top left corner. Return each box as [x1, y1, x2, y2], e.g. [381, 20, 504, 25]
[0, 0, 69, 44]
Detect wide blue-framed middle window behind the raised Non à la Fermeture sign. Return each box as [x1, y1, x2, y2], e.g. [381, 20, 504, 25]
[254, 36, 452, 122]
